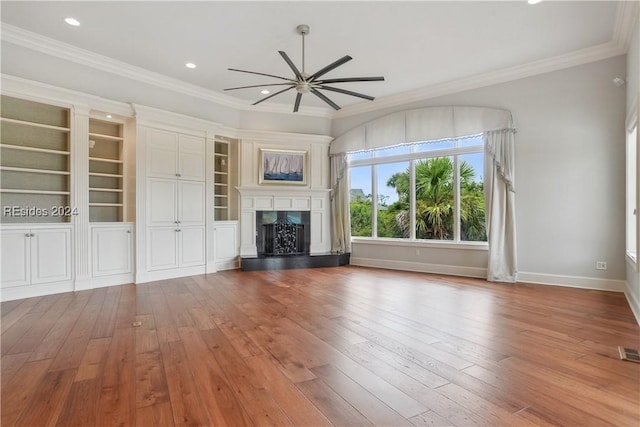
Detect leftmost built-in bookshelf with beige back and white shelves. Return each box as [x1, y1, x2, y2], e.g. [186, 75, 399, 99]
[0, 96, 72, 223]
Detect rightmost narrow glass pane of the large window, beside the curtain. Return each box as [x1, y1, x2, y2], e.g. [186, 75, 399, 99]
[458, 153, 487, 242]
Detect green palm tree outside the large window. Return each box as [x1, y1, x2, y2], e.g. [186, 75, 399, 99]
[387, 157, 486, 240]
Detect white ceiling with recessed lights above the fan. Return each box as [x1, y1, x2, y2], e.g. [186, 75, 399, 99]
[1, 0, 632, 113]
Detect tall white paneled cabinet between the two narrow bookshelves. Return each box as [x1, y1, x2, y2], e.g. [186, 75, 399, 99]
[145, 129, 207, 278]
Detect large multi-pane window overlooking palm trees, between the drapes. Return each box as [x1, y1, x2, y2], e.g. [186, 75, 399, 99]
[349, 135, 487, 242]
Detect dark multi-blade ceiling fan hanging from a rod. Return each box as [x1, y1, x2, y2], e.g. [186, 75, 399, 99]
[224, 25, 384, 113]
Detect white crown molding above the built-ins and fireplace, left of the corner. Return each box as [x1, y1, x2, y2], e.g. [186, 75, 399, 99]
[2, 23, 331, 118]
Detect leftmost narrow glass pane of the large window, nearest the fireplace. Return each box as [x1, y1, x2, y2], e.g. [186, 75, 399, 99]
[349, 166, 373, 237]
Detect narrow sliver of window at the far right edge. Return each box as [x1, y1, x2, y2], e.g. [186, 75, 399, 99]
[626, 126, 638, 262]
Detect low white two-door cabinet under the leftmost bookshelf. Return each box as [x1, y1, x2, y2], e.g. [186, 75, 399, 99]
[2, 225, 72, 291]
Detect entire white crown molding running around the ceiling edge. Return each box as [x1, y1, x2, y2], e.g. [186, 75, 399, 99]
[2, 1, 640, 120]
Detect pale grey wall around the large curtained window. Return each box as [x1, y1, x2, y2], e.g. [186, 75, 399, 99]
[332, 56, 626, 290]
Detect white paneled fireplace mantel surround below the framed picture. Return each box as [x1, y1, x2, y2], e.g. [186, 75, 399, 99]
[236, 185, 331, 257]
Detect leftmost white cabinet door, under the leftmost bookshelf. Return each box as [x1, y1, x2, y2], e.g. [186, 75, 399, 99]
[0, 229, 31, 288]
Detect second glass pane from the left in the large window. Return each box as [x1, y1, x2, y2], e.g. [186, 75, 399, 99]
[376, 162, 411, 238]
